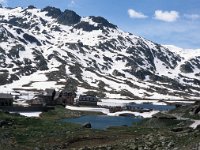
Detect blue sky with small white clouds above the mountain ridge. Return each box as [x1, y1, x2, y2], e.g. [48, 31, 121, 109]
[0, 0, 200, 49]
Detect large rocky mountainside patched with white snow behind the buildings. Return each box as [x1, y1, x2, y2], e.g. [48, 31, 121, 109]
[0, 6, 200, 99]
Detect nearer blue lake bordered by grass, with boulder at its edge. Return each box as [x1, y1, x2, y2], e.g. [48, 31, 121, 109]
[62, 115, 141, 130]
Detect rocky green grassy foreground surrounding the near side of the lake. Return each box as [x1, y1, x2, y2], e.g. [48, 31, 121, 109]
[0, 103, 200, 150]
